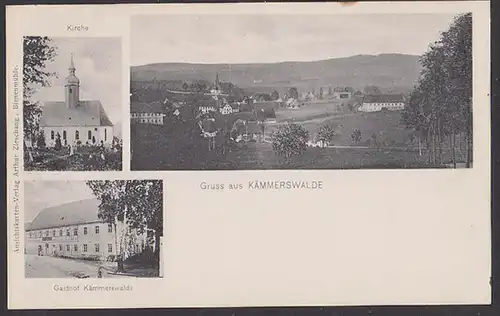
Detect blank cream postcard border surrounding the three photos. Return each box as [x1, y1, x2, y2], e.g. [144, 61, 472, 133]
[6, 1, 491, 309]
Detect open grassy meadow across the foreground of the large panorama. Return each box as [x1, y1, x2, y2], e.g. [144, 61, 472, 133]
[131, 109, 466, 170]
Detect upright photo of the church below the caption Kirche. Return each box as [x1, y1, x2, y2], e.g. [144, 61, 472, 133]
[23, 36, 123, 171]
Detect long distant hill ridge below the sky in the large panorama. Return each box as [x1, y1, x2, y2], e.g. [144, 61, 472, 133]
[130, 54, 420, 92]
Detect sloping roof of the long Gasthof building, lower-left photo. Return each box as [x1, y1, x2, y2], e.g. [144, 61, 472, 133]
[26, 198, 101, 231]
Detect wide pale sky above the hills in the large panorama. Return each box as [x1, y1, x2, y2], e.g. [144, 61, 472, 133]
[130, 14, 453, 66]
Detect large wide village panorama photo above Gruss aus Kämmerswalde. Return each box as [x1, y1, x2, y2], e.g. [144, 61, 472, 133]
[130, 13, 473, 170]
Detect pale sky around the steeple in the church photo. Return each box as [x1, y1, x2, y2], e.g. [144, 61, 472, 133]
[33, 37, 123, 134]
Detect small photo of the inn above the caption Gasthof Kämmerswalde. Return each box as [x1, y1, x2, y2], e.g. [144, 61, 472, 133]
[24, 180, 163, 279]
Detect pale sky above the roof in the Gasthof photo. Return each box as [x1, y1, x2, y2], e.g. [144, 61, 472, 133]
[24, 181, 95, 223]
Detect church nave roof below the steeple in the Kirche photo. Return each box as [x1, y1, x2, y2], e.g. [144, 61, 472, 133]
[40, 100, 113, 127]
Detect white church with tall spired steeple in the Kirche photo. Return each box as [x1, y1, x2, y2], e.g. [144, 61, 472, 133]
[40, 56, 113, 147]
